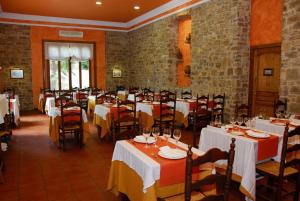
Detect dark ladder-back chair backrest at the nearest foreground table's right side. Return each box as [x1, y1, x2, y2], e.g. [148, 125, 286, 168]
[185, 138, 235, 201]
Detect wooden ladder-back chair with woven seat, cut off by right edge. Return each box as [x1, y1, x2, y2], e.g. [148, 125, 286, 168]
[256, 125, 300, 201]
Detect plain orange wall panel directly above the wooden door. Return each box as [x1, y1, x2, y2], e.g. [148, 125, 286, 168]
[250, 0, 283, 46]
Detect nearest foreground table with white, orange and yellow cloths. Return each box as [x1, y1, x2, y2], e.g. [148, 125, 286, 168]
[108, 136, 214, 201]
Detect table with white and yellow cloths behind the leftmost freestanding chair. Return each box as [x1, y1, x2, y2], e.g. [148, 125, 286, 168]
[48, 107, 90, 145]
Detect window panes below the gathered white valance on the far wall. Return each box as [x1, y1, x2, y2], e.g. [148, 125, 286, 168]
[49, 58, 90, 90]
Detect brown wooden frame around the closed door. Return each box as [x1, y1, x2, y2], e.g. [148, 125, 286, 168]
[248, 43, 281, 116]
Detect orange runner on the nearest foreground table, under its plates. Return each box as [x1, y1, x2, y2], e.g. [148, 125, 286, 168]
[130, 138, 199, 186]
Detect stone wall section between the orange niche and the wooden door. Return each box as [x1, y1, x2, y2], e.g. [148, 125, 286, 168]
[191, 0, 250, 118]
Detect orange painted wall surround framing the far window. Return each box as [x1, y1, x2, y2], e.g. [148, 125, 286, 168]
[31, 26, 105, 107]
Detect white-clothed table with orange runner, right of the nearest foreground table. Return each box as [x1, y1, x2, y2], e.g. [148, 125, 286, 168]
[199, 125, 283, 200]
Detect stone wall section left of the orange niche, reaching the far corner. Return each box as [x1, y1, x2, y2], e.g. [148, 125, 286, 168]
[129, 15, 178, 89]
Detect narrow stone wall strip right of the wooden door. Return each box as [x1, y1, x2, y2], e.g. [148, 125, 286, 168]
[280, 0, 300, 113]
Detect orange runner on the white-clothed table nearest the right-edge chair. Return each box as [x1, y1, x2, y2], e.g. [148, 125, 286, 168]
[227, 128, 279, 161]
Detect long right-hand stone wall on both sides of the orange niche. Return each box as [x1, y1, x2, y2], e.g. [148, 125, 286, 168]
[129, 0, 250, 119]
